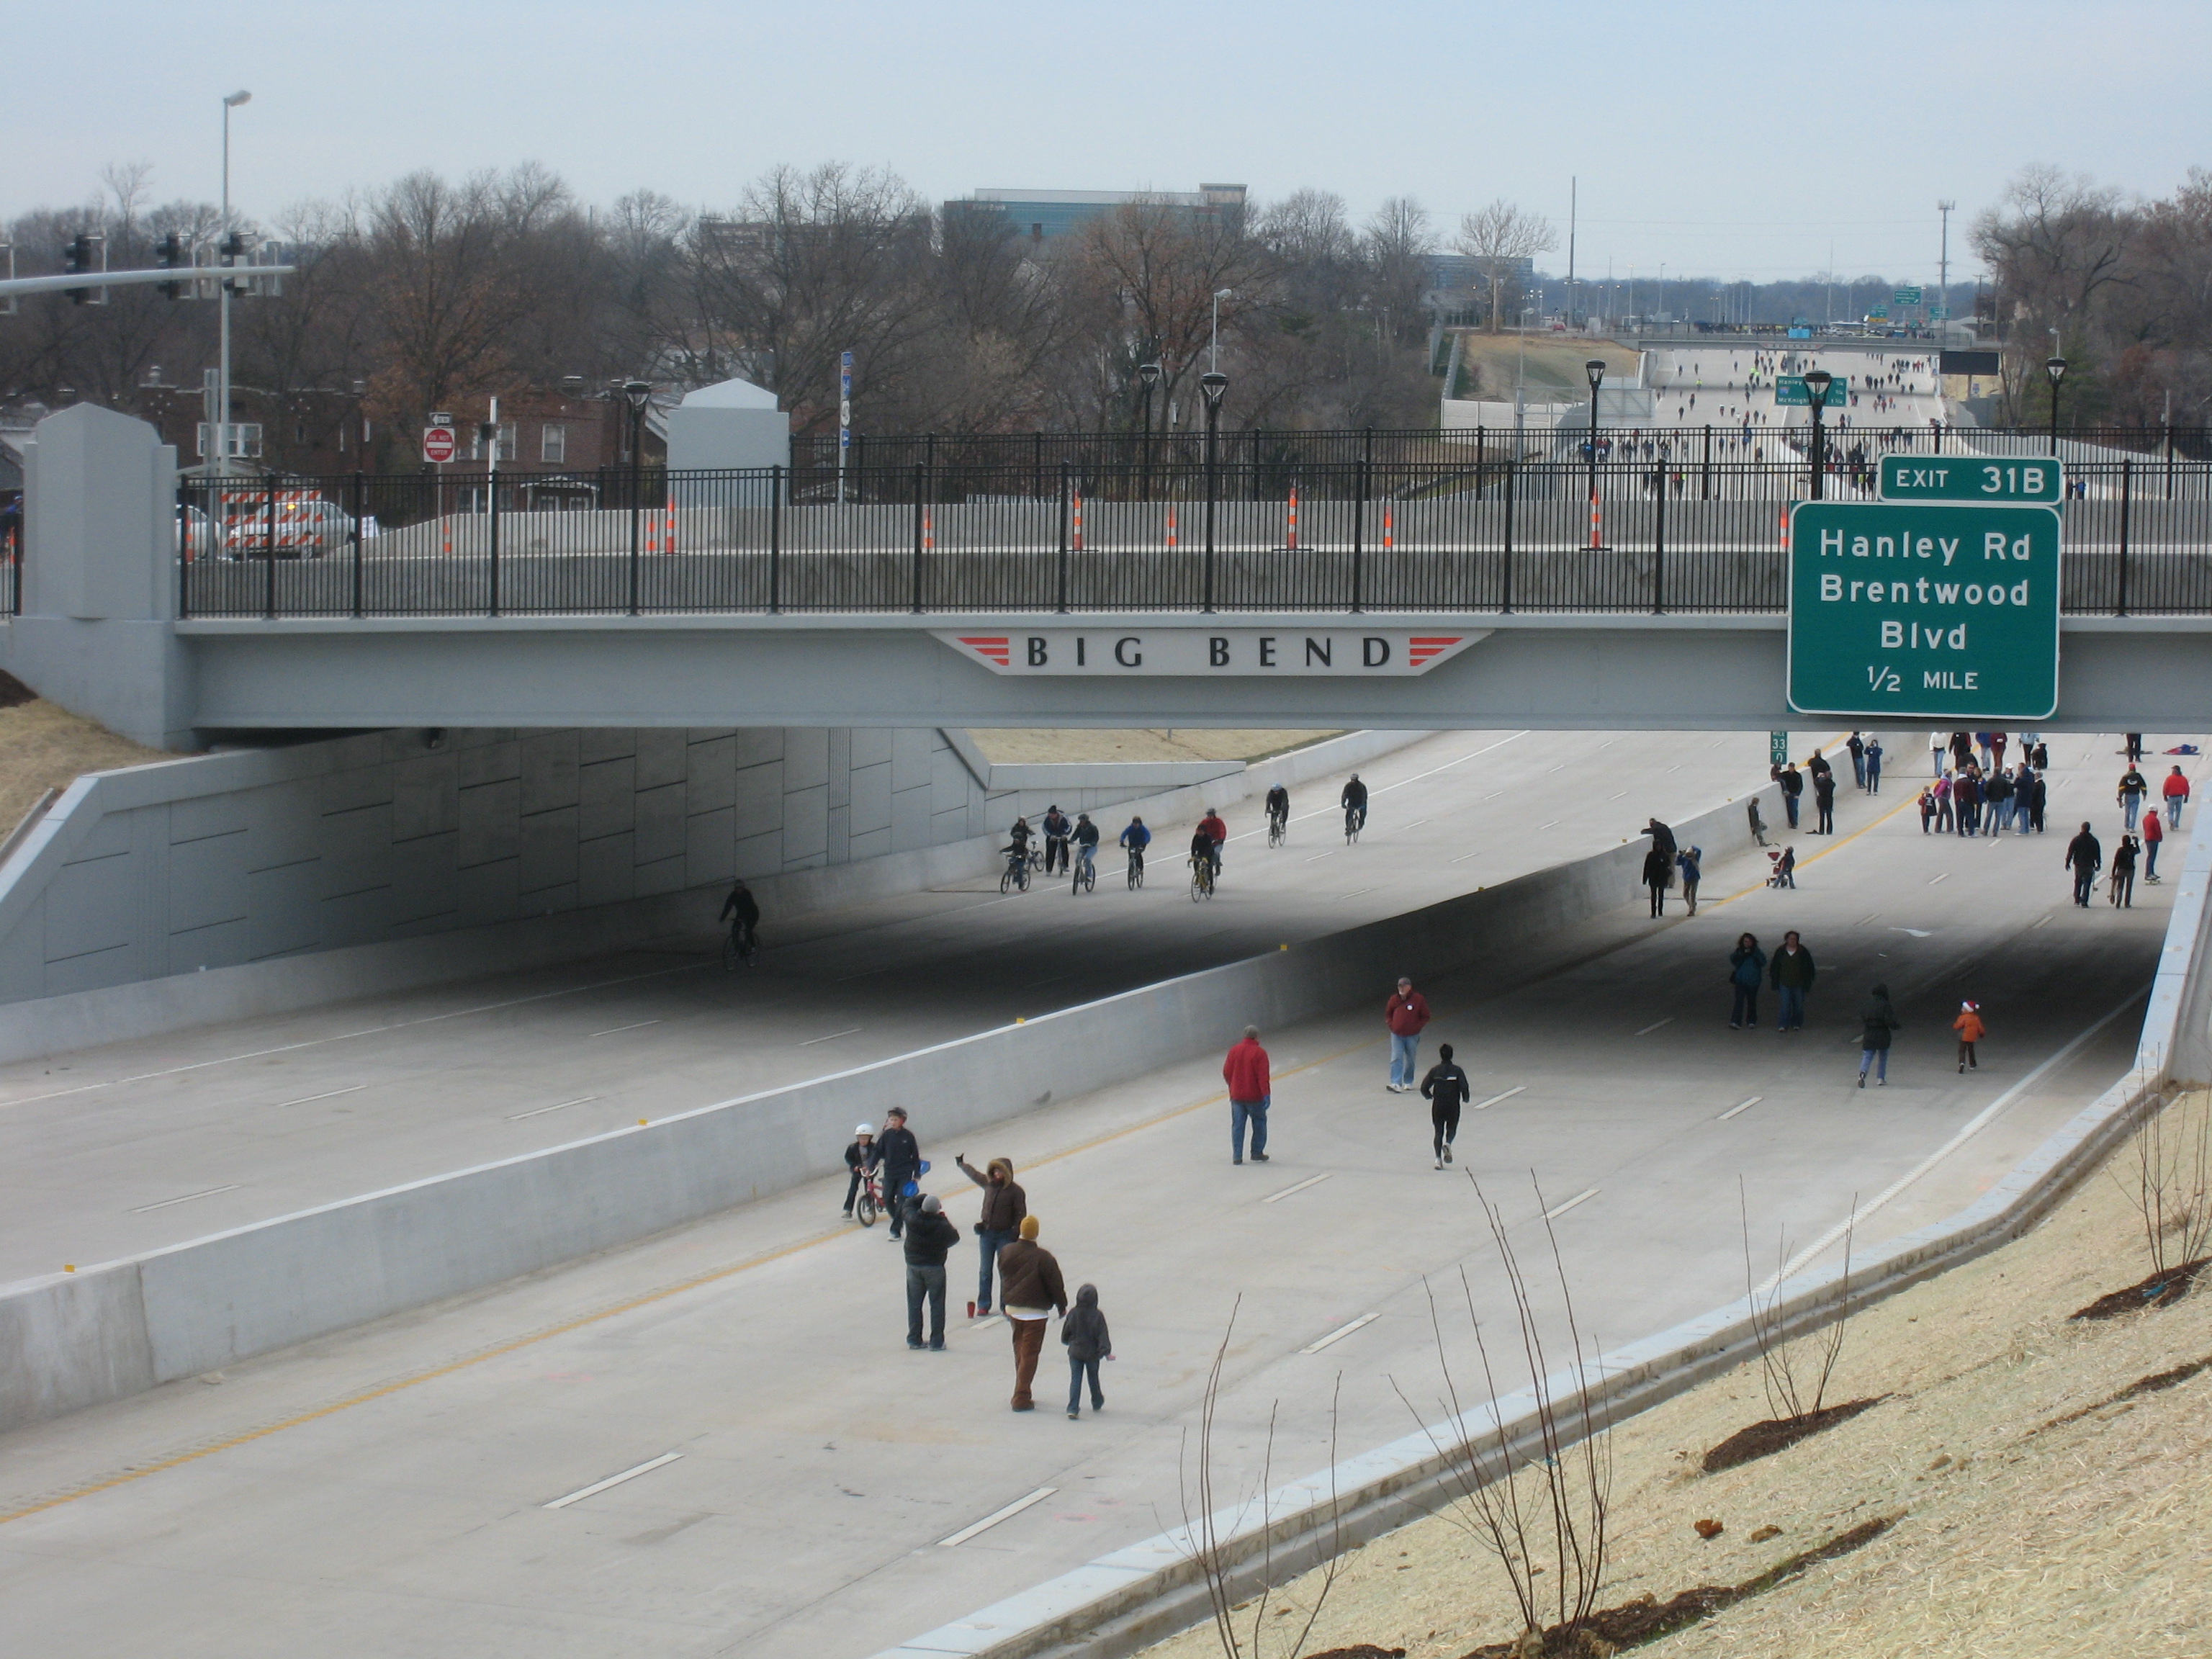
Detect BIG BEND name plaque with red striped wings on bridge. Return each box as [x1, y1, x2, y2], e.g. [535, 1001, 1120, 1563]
[931, 626, 1491, 679]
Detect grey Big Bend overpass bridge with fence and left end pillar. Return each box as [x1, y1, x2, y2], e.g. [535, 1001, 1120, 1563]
[4, 407, 2212, 747]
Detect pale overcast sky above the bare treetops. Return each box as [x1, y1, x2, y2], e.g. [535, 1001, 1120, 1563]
[0, 0, 2212, 281]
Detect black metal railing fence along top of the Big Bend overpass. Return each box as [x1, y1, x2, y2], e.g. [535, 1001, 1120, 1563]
[177, 455, 2212, 617]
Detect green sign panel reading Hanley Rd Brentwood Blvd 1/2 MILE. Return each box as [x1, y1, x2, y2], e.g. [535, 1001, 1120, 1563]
[1787, 502, 2059, 721]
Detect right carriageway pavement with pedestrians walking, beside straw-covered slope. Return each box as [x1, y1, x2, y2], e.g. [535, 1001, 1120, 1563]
[0, 737, 2168, 1659]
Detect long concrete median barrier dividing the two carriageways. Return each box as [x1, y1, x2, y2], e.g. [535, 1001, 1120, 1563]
[0, 765, 1779, 1429]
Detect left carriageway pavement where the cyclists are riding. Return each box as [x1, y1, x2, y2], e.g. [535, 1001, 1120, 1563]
[0, 732, 1765, 1283]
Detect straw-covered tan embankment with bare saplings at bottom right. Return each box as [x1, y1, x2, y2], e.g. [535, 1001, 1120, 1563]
[1153, 1095, 2212, 1659]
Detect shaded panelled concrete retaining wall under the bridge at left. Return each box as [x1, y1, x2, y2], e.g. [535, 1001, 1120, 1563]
[0, 728, 1424, 1059]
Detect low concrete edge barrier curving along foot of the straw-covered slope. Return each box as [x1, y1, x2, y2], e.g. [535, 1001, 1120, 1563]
[878, 801, 2212, 1659]
